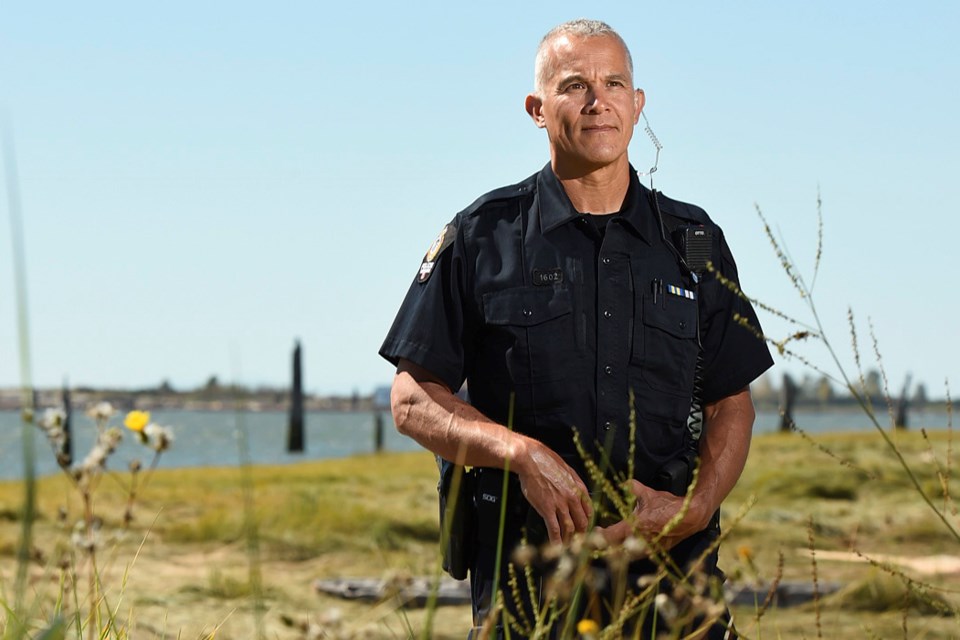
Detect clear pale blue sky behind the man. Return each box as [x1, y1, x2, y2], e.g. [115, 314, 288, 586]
[0, 1, 960, 395]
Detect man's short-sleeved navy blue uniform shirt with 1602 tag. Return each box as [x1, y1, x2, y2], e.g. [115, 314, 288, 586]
[380, 164, 773, 486]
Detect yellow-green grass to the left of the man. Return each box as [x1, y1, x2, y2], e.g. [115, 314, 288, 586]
[0, 454, 458, 638]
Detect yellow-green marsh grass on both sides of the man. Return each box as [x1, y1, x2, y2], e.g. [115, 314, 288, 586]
[0, 432, 960, 638]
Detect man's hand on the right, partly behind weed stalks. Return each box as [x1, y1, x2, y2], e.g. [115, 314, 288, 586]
[597, 480, 709, 549]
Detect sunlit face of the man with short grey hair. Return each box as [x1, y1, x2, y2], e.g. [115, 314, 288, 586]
[526, 35, 643, 175]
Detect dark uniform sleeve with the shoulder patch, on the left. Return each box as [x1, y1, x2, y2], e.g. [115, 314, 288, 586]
[380, 219, 475, 391]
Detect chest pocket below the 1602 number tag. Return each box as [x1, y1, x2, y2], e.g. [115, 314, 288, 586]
[483, 286, 577, 384]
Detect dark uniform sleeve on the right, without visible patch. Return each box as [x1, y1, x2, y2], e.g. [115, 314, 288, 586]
[701, 230, 773, 403]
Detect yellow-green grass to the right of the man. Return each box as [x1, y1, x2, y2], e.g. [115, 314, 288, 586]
[720, 431, 960, 638]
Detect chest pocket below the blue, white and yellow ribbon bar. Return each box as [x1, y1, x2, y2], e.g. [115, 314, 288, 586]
[632, 295, 698, 396]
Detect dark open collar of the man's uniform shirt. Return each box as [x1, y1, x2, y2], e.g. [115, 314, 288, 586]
[537, 163, 659, 244]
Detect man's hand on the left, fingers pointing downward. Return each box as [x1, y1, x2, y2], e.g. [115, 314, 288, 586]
[515, 440, 593, 543]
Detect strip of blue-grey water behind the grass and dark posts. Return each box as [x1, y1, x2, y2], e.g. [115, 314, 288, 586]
[0, 409, 947, 480]
